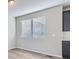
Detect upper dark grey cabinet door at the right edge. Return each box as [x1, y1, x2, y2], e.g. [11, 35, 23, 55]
[63, 11, 70, 31]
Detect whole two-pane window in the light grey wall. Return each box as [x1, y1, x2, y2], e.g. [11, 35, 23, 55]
[21, 16, 46, 38]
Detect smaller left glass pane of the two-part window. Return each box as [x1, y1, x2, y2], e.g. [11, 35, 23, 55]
[21, 20, 31, 37]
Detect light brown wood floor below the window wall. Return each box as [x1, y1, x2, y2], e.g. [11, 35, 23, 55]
[8, 49, 66, 59]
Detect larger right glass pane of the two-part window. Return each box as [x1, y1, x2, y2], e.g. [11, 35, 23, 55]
[33, 16, 46, 38]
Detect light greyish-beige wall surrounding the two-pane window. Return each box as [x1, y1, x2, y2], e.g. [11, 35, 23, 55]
[17, 6, 63, 56]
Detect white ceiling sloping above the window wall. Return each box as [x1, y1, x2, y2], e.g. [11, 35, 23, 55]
[8, 0, 70, 17]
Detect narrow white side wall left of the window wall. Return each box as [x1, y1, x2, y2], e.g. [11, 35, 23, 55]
[8, 13, 16, 50]
